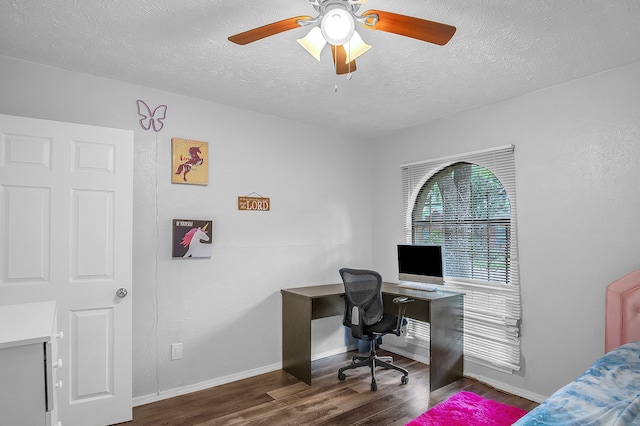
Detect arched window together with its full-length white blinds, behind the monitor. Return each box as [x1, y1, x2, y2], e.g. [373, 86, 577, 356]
[402, 146, 520, 372]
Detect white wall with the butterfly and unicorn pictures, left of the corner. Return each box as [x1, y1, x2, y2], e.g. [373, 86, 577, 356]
[0, 57, 372, 399]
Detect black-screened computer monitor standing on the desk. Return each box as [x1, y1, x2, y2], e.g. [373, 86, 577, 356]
[398, 244, 443, 284]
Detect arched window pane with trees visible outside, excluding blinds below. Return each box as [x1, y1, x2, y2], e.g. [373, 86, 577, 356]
[412, 162, 511, 283]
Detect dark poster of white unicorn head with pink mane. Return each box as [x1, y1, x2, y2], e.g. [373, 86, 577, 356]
[173, 219, 213, 258]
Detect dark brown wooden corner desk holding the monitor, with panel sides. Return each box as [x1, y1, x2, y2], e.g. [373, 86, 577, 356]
[280, 283, 463, 390]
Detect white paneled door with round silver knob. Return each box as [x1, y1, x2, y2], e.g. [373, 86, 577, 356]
[0, 115, 133, 426]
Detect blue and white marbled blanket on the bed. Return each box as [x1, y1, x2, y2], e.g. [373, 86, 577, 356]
[514, 341, 640, 426]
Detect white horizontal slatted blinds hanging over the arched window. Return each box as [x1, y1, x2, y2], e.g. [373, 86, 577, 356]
[401, 145, 521, 372]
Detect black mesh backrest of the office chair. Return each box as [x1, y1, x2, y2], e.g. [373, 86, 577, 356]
[340, 268, 384, 327]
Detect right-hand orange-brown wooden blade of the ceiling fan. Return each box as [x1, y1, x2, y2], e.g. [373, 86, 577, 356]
[362, 10, 456, 46]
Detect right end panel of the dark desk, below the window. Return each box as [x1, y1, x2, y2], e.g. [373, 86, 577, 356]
[429, 295, 464, 391]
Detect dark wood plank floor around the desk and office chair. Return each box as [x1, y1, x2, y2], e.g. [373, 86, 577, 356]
[121, 351, 538, 426]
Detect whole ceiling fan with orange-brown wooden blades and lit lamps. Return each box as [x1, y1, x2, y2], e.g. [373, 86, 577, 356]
[229, 0, 456, 74]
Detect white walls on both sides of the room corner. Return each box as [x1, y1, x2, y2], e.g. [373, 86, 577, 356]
[5, 57, 640, 398]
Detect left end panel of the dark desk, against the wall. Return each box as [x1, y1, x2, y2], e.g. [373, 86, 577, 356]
[282, 291, 311, 385]
